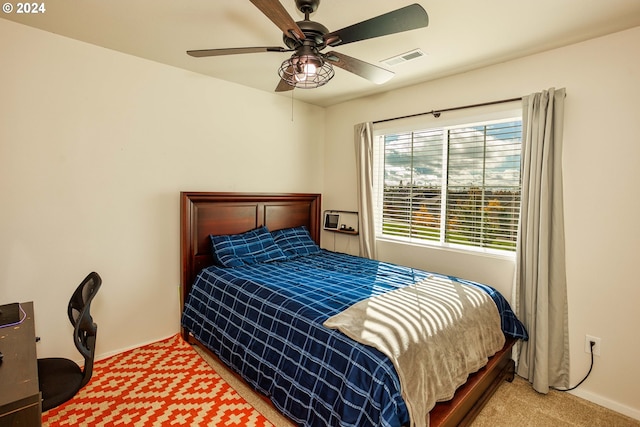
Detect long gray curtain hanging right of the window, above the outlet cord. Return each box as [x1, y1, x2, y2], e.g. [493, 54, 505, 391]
[515, 88, 569, 393]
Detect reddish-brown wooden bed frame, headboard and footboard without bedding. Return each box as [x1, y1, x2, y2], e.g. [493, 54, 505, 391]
[180, 192, 516, 427]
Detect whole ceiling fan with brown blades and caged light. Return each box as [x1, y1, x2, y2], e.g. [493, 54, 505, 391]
[187, 0, 429, 92]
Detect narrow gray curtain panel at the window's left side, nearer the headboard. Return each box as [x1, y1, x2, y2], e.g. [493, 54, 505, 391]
[354, 122, 376, 259]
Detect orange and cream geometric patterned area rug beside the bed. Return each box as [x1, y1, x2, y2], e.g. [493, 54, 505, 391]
[42, 335, 273, 427]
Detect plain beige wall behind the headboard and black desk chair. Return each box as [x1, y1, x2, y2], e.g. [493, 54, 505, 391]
[0, 19, 324, 358]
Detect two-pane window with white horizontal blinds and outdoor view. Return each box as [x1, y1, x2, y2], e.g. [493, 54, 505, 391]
[374, 112, 522, 251]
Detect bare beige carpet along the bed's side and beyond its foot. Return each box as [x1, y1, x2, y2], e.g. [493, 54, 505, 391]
[195, 346, 640, 427]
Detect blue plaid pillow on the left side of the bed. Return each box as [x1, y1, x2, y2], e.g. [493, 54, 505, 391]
[209, 227, 287, 267]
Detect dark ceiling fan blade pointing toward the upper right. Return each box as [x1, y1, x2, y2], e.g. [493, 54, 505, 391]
[324, 3, 429, 46]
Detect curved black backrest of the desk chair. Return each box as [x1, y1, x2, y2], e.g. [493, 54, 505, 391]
[67, 272, 102, 386]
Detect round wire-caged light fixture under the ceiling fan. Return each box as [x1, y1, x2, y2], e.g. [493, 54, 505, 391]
[278, 55, 334, 89]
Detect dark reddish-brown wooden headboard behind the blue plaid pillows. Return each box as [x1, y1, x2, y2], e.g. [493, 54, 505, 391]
[180, 191, 321, 308]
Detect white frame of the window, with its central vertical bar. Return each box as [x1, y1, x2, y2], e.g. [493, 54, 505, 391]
[373, 103, 522, 259]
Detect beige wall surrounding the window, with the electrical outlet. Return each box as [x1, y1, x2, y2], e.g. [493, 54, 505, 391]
[324, 28, 640, 419]
